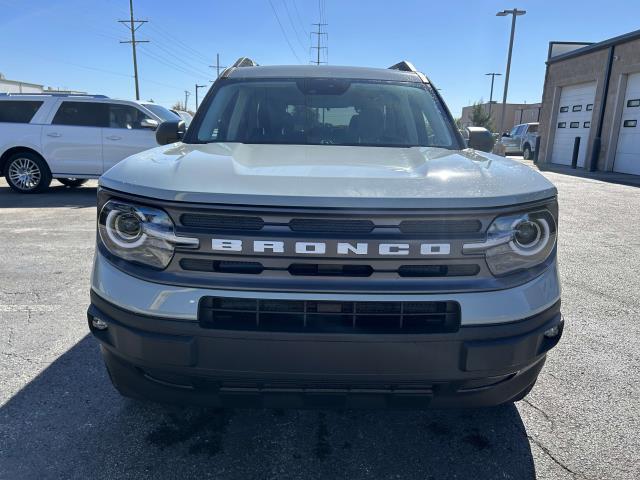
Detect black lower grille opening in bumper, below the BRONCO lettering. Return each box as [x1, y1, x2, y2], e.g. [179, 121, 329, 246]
[198, 297, 460, 334]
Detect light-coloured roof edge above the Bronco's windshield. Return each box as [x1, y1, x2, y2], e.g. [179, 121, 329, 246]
[229, 65, 421, 83]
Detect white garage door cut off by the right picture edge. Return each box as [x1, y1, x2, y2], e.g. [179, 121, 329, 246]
[613, 73, 640, 175]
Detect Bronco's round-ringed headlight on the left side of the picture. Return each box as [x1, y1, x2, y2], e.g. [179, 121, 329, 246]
[98, 200, 198, 269]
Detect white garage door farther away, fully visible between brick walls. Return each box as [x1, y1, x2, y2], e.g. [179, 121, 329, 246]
[551, 82, 596, 167]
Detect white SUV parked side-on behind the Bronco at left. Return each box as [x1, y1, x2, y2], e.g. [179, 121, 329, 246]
[0, 94, 177, 193]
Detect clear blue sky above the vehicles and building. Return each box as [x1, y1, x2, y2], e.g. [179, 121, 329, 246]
[0, 0, 640, 116]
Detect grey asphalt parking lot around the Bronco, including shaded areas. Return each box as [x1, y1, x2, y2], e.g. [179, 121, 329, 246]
[0, 172, 640, 479]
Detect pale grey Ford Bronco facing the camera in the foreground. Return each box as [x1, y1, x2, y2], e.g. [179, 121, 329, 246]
[87, 58, 563, 408]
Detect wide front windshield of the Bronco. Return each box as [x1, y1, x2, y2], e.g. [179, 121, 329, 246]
[194, 78, 457, 148]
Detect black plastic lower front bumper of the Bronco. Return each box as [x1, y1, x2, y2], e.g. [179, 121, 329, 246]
[88, 291, 563, 408]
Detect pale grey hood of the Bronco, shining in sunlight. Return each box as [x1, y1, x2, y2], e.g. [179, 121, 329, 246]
[100, 143, 557, 208]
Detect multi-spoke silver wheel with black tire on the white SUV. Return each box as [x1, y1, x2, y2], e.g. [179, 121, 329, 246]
[4, 152, 51, 193]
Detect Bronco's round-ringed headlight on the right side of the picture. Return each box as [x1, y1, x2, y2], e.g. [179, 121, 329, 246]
[463, 210, 557, 276]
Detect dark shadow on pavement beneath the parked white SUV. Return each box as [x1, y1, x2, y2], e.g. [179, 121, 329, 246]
[0, 181, 97, 208]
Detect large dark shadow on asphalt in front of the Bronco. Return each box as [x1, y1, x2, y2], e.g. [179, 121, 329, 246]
[0, 336, 535, 479]
